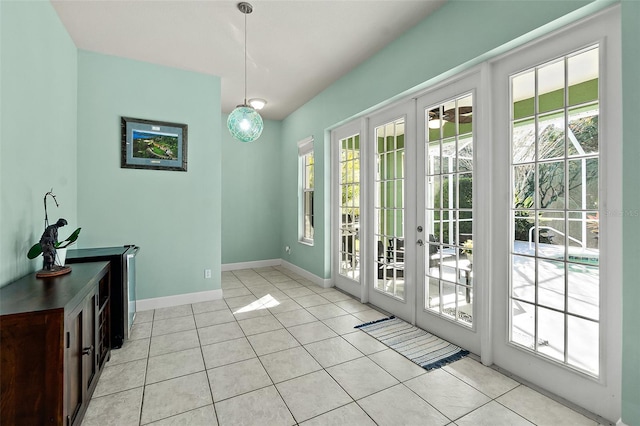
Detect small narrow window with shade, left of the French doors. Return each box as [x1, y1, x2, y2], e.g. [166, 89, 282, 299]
[298, 137, 314, 244]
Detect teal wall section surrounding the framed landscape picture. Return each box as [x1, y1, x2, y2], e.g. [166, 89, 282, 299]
[77, 51, 222, 299]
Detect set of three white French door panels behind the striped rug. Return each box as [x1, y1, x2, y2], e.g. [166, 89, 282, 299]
[332, 78, 489, 353]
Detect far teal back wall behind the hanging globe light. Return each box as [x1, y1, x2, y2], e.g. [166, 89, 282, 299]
[222, 114, 282, 264]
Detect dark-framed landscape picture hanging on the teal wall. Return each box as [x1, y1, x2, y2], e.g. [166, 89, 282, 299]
[120, 117, 187, 172]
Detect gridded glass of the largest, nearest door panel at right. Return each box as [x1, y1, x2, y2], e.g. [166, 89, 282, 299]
[510, 46, 600, 376]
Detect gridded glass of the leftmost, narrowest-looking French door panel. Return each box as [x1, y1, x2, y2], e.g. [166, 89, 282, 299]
[339, 135, 360, 280]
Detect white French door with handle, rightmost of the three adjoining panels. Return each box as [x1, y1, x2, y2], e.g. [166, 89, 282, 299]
[415, 71, 486, 354]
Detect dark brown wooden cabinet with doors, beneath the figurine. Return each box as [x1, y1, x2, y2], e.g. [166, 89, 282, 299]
[0, 262, 111, 426]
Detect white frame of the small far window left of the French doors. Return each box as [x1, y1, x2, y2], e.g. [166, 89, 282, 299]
[298, 136, 315, 245]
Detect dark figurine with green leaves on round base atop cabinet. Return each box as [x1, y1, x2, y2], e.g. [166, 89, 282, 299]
[27, 189, 82, 278]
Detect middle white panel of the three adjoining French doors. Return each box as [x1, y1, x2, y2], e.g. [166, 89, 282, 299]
[365, 101, 417, 323]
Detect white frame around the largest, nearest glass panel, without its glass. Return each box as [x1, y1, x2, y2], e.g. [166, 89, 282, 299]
[490, 6, 622, 419]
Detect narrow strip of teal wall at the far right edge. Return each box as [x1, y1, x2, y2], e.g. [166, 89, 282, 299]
[622, 1, 640, 425]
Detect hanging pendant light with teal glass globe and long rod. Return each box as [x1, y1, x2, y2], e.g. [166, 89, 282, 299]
[227, 2, 266, 142]
